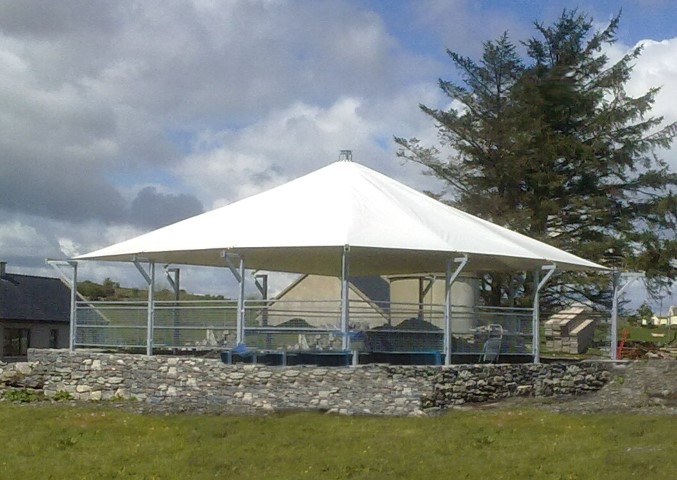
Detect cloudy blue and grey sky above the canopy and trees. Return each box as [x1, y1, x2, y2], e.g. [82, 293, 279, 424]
[0, 0, 677, 310]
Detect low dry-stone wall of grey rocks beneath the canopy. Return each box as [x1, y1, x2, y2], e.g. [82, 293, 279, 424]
[0, 349, 610, 415]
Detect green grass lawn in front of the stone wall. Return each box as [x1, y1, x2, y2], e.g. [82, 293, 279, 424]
[0, 403, 677, 480]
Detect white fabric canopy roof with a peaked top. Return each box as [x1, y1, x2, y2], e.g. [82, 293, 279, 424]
[75, 161, 605, 276]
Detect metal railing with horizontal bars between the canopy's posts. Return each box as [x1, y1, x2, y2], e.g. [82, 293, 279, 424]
[74, 300, 533, 355]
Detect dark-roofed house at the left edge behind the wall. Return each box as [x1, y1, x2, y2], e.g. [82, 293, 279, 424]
[0, 262, 70, 360]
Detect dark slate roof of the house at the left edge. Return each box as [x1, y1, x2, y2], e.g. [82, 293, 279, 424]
[0, 273, 71, 322]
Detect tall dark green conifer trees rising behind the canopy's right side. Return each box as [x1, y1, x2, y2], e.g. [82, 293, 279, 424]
[395, 10, 677, 305]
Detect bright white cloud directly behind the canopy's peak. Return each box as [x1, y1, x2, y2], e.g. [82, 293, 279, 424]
[174, 85, 439, 206]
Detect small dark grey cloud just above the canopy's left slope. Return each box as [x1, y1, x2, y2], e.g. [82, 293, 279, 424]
[129, 187, 204, 229]
